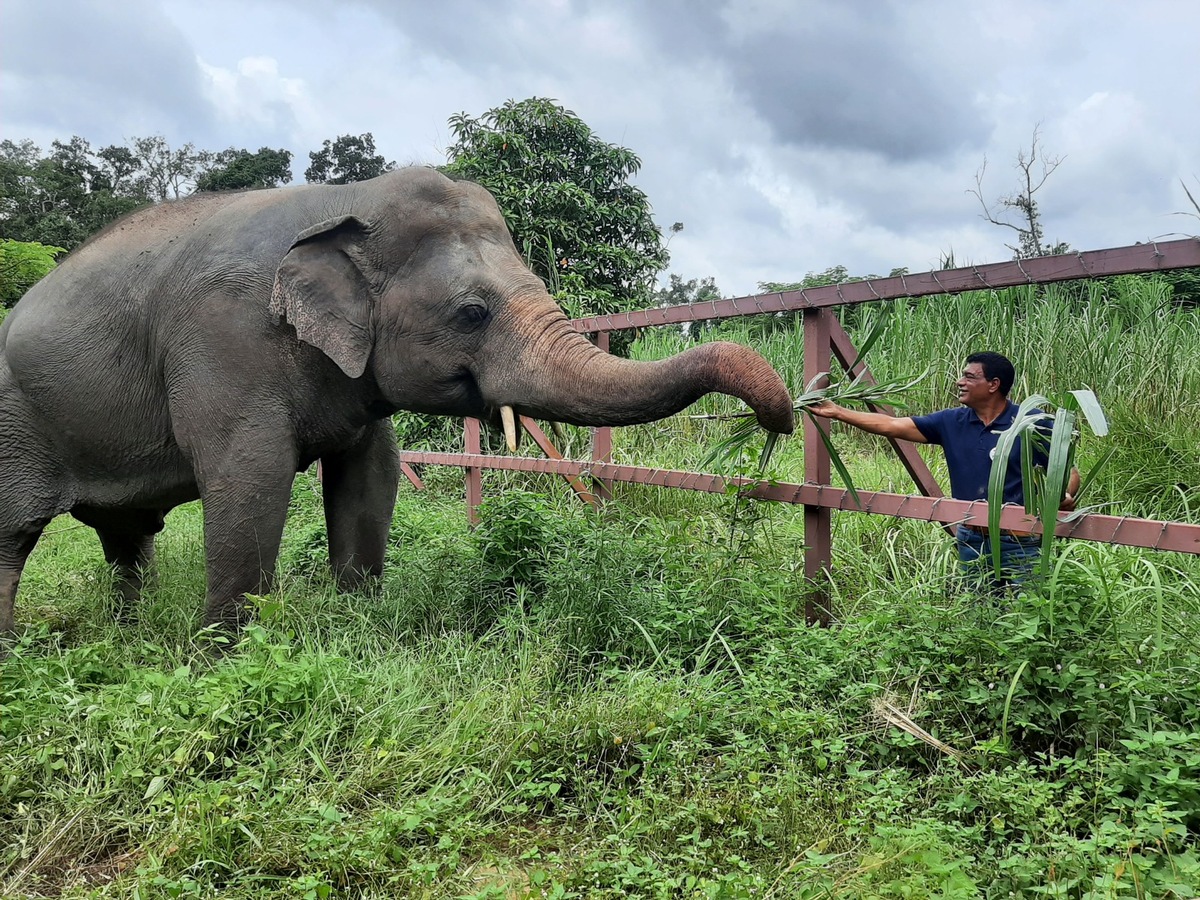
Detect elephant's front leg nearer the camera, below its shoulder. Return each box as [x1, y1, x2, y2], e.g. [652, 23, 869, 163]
[200, 465, 295, 629]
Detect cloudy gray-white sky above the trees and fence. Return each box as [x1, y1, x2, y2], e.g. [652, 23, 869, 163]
[0, 0, 1200, 294]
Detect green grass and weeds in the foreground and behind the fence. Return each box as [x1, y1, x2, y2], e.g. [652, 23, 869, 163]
[0, 278, 1200, 899]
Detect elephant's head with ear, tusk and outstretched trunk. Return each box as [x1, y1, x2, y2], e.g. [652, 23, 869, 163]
[271, 168, 794, 443]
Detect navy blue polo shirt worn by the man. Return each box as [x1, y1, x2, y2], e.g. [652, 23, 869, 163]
[912, 401, 1048, 504]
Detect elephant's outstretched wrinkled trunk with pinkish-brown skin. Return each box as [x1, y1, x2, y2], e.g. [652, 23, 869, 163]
[502, 322, 796, 434]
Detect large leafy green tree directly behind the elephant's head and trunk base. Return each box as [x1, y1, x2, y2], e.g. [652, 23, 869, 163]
[444, 97, 667, 336]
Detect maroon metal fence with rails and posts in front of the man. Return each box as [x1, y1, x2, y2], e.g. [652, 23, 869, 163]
[401, 238, 1200, 622]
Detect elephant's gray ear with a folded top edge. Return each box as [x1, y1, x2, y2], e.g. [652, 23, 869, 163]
[271, 216, 374, 378]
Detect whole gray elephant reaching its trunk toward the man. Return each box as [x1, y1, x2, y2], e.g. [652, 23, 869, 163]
[0, 168, 793, 632]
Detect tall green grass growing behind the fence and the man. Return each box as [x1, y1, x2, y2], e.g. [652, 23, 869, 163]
[619, 276, 1200, 520]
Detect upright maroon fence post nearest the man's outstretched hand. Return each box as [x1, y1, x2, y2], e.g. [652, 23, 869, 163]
[803, 310, 833, 625]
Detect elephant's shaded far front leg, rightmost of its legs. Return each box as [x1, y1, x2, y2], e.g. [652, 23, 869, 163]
[320, 419, 400, 590]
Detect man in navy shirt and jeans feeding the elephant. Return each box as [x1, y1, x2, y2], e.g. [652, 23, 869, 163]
[811, 352, 1079, 586]
